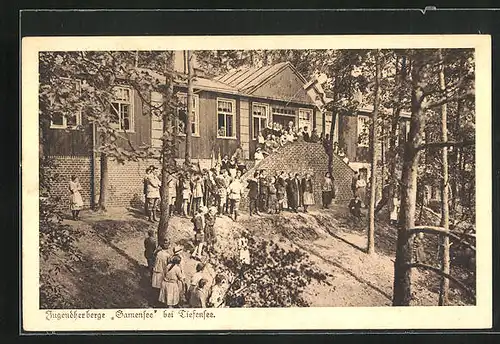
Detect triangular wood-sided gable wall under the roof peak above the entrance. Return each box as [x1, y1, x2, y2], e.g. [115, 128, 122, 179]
[252, 66, 313, 104]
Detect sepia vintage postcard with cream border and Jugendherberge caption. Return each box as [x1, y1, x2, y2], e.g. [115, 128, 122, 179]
[21, 35, 492, 332]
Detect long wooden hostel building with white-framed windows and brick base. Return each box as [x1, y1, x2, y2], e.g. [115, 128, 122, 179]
[44, 52, 412, 206]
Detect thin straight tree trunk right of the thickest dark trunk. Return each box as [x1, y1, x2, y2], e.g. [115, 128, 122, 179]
[439, 49, 450, 306]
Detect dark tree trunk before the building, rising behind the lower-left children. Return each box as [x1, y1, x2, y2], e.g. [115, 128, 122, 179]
[158, 52, 177, 244]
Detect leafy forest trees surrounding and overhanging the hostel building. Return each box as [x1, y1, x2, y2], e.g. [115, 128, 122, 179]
[39, 49, 475, 306]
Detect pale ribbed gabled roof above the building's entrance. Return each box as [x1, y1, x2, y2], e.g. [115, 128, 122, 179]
[215, 62, 306, 94]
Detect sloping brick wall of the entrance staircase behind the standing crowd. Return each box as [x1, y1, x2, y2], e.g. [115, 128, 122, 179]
[243, 142, 354, 204]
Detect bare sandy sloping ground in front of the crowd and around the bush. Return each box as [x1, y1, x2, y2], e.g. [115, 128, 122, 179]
[40, 206, 472, 308]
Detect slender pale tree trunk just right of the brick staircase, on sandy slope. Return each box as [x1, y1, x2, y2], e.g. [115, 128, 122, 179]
[367, 50, 382, 254]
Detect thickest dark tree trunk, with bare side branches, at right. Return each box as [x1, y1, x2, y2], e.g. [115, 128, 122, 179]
[392, 53, 425, 306]
